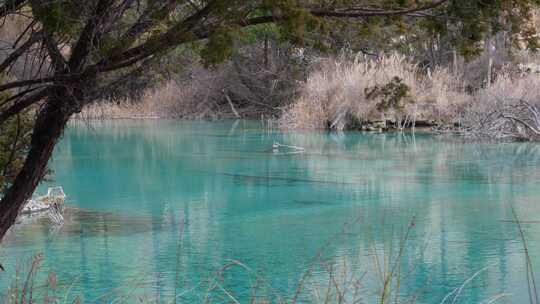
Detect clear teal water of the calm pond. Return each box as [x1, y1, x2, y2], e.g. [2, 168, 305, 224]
[0, 121, 540, 303]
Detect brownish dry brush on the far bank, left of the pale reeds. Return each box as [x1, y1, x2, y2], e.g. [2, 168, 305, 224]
[74, 70, 282, 120]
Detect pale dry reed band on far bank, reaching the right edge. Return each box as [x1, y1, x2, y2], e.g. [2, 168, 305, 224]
[279, 54, 540, 130]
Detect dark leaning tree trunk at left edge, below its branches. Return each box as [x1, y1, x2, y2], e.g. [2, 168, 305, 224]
[0, 94, 71, 241]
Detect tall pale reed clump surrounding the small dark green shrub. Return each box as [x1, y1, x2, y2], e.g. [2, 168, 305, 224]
[280, 54, 465, 130]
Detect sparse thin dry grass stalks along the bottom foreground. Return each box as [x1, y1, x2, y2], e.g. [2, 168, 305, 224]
[2, 215, 538, 304]
